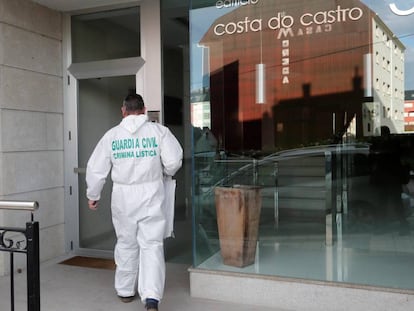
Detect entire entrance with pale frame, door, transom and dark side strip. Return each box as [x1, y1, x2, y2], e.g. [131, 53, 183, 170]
[64, 0, 192, 264]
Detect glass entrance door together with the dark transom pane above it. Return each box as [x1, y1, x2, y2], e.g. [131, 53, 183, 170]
[65, 7, 145, 258]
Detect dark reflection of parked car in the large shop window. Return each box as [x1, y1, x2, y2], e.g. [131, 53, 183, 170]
[195, 141, 414, 239]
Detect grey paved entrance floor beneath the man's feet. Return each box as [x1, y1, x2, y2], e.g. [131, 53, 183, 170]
[0, 258, 283, 311]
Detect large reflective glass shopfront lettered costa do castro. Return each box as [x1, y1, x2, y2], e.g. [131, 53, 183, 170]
[190, 0, 414, 289]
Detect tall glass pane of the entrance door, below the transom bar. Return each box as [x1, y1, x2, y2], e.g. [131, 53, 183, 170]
[78, 76, 135, 251]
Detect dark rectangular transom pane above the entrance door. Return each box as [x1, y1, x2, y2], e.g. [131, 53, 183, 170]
[72, 7, 141, 63]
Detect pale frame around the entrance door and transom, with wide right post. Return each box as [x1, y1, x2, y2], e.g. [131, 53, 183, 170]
[62, 0, 163, 258]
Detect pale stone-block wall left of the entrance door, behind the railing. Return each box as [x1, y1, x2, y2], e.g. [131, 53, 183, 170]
[0, 0, 64, 274]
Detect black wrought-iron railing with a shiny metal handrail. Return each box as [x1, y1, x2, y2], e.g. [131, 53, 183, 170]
[0, 201, 40, 311]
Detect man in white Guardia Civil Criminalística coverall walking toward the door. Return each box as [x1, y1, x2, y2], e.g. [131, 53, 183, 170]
[86, 94, 183, 311]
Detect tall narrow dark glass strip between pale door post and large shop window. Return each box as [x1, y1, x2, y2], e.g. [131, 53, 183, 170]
[161, 0, 192, 264]
